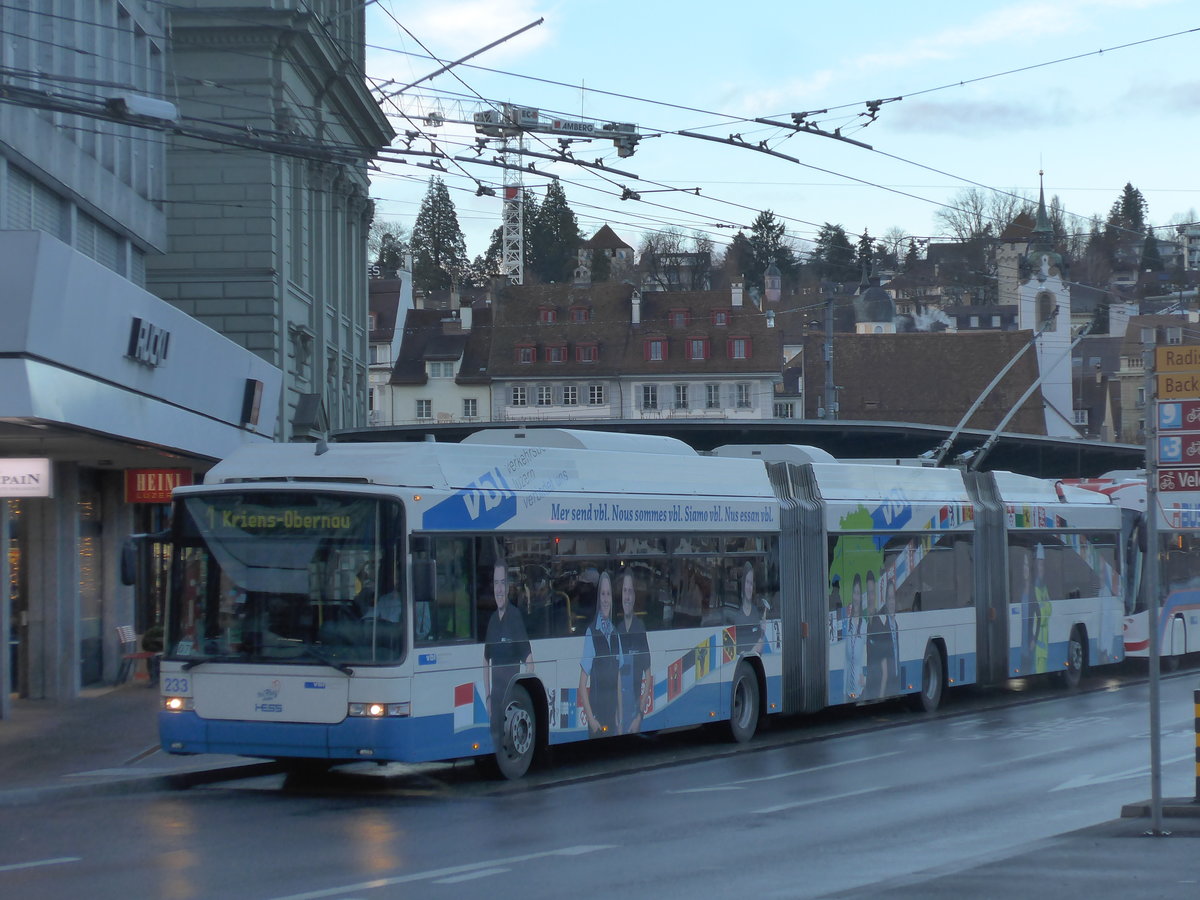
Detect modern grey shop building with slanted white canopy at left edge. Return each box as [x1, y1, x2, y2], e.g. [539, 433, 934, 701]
[0, 0, 281, 715]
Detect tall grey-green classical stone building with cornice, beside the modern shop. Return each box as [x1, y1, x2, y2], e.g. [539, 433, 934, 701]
[146, 0, 394, 440]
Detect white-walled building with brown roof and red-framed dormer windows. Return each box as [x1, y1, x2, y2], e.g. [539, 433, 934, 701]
[487, 283, 782, 422]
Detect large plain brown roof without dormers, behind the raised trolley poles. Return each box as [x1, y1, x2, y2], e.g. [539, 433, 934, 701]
[804, 331, 1045, 434]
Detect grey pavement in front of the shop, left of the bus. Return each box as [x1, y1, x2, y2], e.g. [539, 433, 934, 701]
[0, 682, 275, 806]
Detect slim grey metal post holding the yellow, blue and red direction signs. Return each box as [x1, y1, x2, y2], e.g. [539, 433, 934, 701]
[1141, 344, 1166, 836]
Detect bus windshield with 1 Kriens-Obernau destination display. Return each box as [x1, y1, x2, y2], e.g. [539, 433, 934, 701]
[166, 491, 407, 668]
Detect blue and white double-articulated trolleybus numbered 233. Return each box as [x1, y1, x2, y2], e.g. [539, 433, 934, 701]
[160, 428, 1123, 778]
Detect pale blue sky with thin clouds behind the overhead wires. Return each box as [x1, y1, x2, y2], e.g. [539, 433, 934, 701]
[367, 0, 1200, 257]
